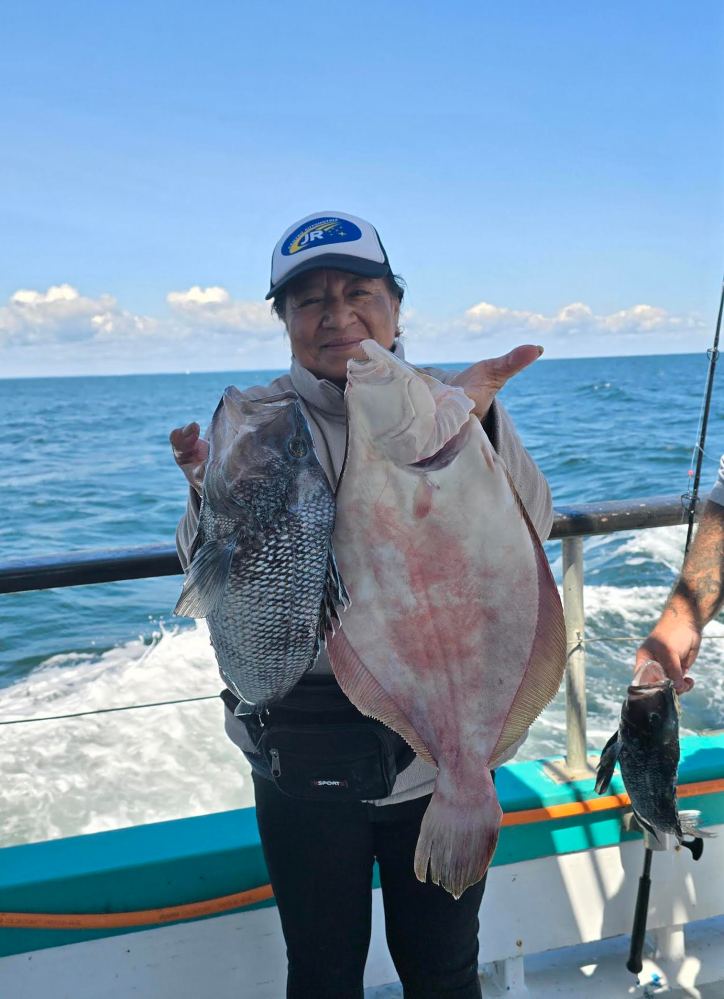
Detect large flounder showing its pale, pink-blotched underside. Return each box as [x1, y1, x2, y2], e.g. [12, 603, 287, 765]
[328, 340, 566, 897]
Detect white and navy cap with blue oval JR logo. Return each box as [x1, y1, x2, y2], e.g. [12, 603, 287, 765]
[266, 212, 391, 298]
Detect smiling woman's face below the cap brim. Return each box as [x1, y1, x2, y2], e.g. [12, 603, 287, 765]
[284, 269, 400, 384]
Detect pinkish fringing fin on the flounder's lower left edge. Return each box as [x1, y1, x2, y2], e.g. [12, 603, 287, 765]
[327, 628, 437, 766]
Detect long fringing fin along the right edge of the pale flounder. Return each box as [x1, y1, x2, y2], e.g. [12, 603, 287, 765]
[490, 472, 566, 765]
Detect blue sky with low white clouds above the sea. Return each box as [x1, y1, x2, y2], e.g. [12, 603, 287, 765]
[0, 0, 724, 376]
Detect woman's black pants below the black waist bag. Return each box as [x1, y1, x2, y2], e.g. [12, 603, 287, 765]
[254, 774, 485, 999]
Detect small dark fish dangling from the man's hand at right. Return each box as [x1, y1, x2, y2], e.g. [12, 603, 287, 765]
[596, 660, 706, 858]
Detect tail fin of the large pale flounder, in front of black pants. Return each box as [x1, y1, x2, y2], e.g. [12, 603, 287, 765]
[415, 770, 503, 898]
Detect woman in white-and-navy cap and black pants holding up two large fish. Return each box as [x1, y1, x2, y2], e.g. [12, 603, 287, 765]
[171, 213, 553, 999]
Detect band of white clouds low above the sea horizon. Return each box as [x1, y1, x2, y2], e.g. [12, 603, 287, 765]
[0, 284, 709, 376]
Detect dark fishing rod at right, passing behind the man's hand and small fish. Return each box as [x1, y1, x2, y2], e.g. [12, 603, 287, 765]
[626, 281, 724, 975]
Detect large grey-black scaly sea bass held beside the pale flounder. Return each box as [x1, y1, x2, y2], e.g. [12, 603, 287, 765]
[174, 387, 346, 713]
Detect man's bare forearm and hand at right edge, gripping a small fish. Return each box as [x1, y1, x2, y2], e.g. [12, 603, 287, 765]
[636, 500, 724, 693]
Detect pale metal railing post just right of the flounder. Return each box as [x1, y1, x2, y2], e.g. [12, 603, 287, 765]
[561, 538, 587, 776]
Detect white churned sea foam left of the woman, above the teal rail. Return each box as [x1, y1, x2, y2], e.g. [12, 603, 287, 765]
[0, 623, 253, 846]
